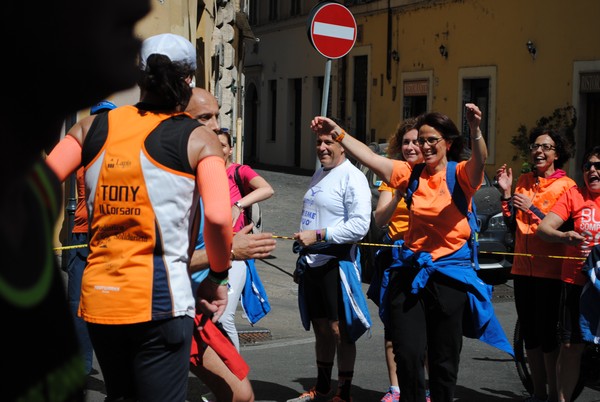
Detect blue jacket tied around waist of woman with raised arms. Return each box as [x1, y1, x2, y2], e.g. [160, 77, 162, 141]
[379, 240, 514, 357]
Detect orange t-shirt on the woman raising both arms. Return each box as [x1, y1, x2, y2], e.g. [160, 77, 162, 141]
[390, 161, 477, 260]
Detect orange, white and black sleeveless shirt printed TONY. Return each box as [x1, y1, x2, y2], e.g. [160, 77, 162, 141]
[79, 106, 199, 324]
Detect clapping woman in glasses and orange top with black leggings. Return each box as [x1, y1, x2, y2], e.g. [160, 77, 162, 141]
[496, 128, 575, 400]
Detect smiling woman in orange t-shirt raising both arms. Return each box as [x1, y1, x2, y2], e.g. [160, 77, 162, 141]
[311, 103, 512, 400]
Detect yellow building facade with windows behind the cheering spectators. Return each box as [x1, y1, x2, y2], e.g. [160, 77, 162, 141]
[244, 0, 600, 182]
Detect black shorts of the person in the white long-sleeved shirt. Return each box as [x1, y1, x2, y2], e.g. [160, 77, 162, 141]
[304, 259, 342, 321]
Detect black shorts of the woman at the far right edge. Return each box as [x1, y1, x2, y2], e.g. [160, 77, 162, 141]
[558, 283, 583, 343]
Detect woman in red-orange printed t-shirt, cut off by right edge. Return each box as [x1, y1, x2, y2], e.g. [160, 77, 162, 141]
[538, 146, 600, 401]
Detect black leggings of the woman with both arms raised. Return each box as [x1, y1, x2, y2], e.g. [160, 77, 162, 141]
[390, 269, 467, 402]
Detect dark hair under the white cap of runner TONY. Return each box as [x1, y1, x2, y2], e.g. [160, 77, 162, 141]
[138, 54, 195, 109]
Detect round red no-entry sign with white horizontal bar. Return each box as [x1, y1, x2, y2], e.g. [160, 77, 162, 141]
[308, 2, 356, 59]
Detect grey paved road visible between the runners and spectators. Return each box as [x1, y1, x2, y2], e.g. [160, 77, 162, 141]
[82, 170, 600, 402]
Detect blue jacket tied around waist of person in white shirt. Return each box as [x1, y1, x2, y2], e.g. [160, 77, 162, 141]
[293, 242, 371, 342]
